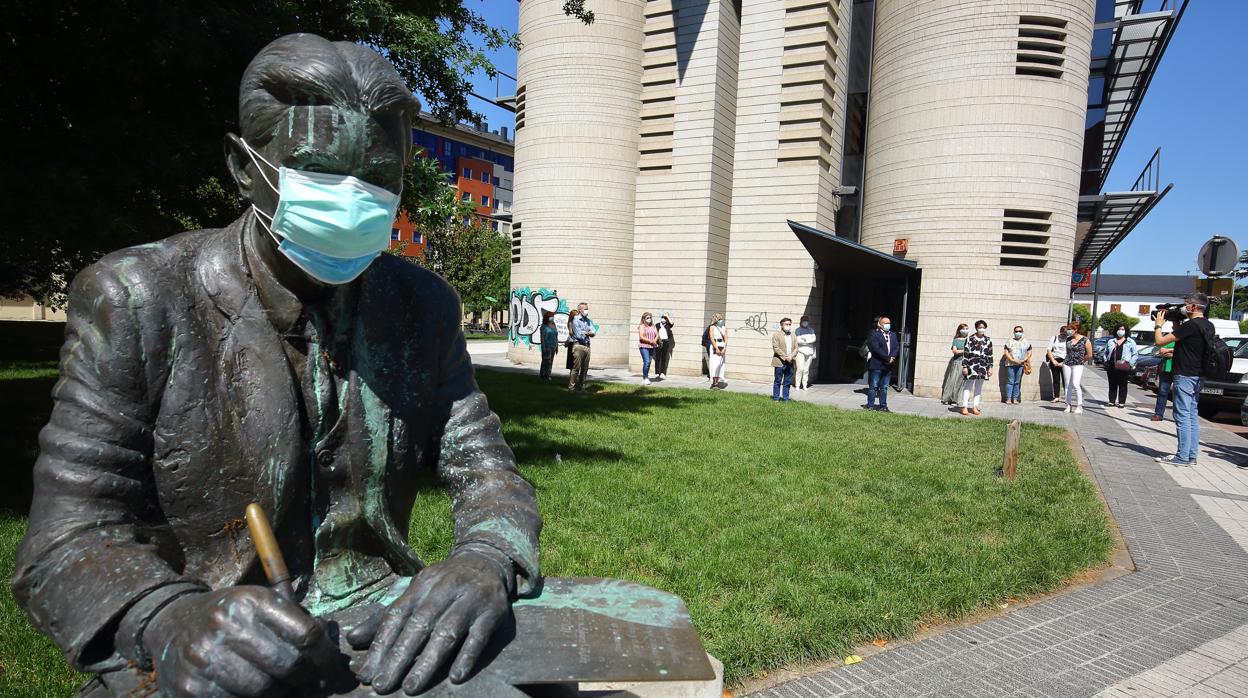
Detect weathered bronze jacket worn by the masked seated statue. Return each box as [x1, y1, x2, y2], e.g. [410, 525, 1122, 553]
[12, 216, 540, 672]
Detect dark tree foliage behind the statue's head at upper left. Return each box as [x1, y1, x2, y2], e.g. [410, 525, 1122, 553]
[0, 0, 516, 303]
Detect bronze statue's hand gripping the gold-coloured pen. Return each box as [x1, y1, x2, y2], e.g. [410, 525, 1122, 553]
[142, 586, 338, 697]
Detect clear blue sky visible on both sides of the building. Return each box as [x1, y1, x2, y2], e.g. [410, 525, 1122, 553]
[446, 0, 1248, 275]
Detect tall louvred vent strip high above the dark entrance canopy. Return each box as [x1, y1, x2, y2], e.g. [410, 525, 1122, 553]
[776, 0, 840, 167]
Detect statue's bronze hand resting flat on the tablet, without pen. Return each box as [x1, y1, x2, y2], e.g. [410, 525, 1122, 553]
[347, 553, 509, 694]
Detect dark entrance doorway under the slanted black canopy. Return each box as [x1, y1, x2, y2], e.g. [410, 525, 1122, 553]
[789, 221, 920, 390]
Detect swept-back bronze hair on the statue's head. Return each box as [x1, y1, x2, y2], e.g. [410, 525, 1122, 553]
[238, 34, 421, 156]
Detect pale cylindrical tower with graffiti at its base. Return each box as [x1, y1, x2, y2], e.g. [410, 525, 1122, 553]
[508, 0, 645, 365]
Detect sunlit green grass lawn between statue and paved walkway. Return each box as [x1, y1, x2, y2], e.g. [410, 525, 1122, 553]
[0, 371, 1112, 696]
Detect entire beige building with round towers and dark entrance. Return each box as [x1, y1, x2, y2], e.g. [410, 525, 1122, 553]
[510, 0, 1181, 397]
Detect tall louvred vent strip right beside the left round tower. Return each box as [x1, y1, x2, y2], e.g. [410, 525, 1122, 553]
[638, 0, 676, 172]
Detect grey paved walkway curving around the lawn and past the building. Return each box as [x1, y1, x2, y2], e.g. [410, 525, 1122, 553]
[473, 350, 1248, 698]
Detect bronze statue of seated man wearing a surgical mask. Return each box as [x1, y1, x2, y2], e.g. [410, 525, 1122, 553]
[12, 34, 542, 696]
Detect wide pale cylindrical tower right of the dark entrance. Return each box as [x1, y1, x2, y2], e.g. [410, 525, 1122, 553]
[861, 0, 1094, 397]
